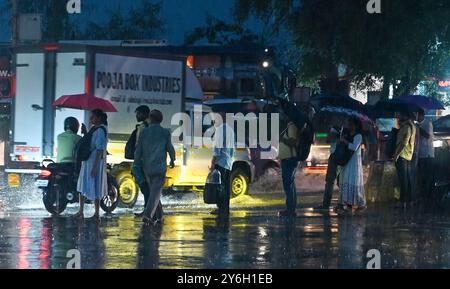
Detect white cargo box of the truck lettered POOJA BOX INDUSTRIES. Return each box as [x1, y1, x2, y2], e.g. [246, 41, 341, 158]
[5, 43, 187, 195]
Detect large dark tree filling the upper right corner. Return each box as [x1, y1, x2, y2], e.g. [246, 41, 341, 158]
[239, 0, 450, 95]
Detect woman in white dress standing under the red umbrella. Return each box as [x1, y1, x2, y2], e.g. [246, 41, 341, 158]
[75, 109, 108, 218]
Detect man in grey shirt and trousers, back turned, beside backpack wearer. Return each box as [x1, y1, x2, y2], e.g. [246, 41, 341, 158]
[134, 110, 175, 224]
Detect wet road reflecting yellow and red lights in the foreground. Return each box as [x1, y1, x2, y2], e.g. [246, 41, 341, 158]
[0, 190, 450, 269]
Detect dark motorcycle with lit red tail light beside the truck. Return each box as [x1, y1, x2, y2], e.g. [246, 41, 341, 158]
[35, 160, 119, 215]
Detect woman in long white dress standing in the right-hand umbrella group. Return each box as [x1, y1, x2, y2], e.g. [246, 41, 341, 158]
[339, 118, 366, 213]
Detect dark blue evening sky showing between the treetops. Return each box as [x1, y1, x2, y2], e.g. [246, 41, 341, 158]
[0, 0, 257, 44]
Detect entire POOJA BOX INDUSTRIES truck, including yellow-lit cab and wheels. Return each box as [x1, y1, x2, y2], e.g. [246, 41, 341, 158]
[5, 42, 276, 207]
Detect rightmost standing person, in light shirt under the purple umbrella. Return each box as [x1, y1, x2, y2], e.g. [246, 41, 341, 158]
[418, 109, 434, 200]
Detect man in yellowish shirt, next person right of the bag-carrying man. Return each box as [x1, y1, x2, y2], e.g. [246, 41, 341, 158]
[278, 121, 300, 217]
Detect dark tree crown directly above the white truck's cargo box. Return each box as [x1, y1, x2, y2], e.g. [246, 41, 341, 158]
[83, 0, 164, 40]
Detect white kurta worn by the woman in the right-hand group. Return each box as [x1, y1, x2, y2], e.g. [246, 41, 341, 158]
[339, 134, 366, 206]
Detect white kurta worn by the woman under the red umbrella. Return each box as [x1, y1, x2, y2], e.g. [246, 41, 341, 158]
[77, 126, 108, 201]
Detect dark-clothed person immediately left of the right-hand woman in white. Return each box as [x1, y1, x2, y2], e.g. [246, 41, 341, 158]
[314, 127, 339, 211]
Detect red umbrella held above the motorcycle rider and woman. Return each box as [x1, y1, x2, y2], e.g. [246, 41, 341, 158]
[53, 93, 117, 112]
